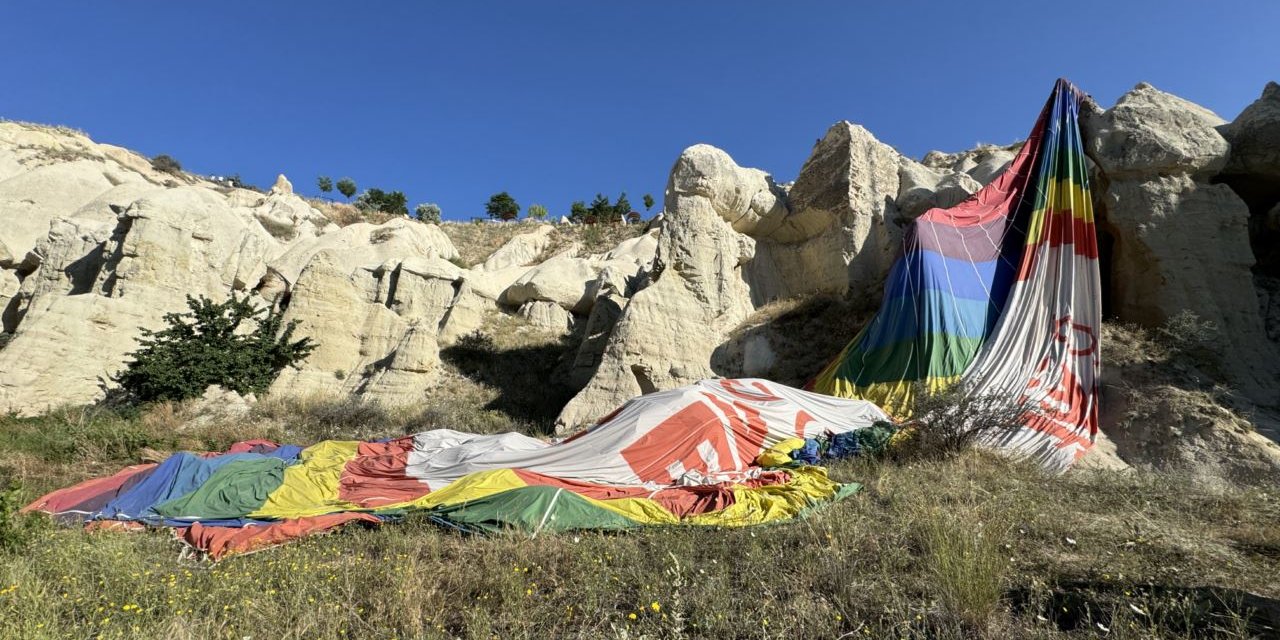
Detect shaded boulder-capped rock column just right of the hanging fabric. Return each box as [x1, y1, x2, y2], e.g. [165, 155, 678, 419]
[1082, 84, 1280, 403]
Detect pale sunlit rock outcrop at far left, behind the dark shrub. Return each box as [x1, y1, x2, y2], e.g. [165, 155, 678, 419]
[0, 187, 278, 413]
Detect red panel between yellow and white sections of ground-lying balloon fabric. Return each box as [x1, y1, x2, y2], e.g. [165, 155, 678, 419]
[338, 435, 430, 508]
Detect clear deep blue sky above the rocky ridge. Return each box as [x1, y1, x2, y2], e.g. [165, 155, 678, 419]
[0, 0, 1280, 219]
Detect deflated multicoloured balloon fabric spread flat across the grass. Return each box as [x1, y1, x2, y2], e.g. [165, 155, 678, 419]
[24, 379, 887, 558]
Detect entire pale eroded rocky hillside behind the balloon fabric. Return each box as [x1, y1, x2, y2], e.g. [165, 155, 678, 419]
[0, 83, 1280, 476]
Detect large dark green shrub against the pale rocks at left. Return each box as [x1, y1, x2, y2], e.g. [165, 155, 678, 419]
[115, 294, 315, 402]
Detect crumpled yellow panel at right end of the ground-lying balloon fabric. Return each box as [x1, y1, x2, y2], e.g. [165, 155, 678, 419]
[685, 467, 838, 526]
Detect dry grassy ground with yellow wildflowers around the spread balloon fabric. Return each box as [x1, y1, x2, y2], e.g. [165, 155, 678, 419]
[0, 401, 1280, 637]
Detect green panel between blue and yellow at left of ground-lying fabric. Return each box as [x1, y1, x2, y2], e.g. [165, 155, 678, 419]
[155, 457, 288, 520]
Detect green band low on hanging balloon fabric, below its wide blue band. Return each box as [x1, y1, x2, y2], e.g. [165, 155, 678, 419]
[836, 333, 983, 387]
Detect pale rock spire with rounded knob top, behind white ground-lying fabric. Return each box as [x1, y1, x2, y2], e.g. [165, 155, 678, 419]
[557, 145, 762, 433]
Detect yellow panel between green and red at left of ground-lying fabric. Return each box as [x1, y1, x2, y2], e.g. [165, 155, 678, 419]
[248, 440, 360, 518]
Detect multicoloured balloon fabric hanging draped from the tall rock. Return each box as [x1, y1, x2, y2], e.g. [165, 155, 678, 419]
[812, 79, 1102, 470]
